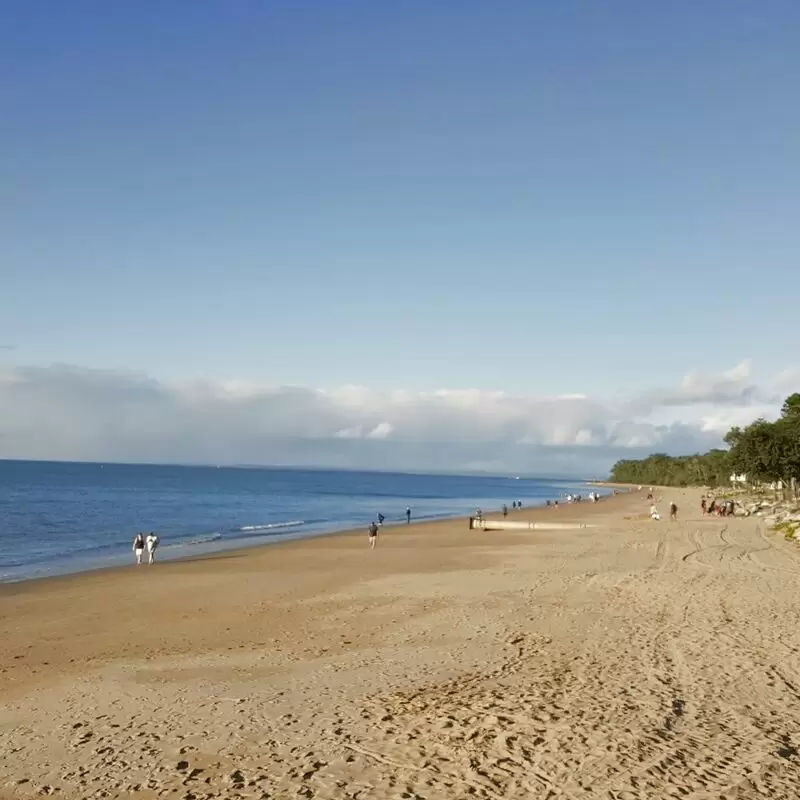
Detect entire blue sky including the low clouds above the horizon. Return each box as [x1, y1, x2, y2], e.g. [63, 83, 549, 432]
[0, 0, 800, 473]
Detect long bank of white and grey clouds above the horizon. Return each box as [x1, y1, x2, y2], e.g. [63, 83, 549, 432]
[0, 361, 800, 476]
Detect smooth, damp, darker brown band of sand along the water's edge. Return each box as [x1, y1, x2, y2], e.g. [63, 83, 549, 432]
[0, 494, 642, 689]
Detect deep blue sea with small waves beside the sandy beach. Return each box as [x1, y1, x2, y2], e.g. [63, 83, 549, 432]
[0, 461, 600, 582]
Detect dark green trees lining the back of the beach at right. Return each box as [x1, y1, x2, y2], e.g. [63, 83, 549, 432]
[610, 392, 800, 486]
